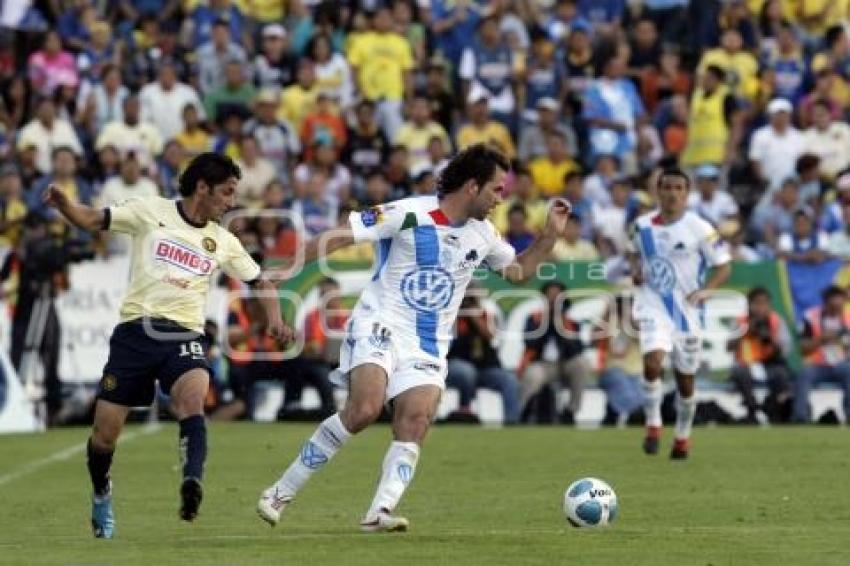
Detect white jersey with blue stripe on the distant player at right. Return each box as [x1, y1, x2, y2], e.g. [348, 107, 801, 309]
[632, 211, 731, 333]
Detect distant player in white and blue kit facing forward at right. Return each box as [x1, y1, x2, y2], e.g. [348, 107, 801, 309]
[630, 168, 731, 459]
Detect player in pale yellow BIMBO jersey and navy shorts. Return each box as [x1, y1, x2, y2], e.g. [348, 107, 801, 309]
[44, 153, 292, 538]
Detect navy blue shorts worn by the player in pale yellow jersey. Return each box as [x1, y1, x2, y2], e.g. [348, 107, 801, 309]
[97, 319, 210, 407]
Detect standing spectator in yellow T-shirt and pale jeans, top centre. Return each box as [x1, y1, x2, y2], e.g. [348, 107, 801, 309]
[348, 6, 413, 139]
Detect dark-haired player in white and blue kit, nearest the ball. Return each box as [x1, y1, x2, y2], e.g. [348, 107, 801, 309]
[257, 145, 569, 532]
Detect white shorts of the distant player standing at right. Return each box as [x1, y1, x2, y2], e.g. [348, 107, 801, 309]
[636, 310, 702, 375]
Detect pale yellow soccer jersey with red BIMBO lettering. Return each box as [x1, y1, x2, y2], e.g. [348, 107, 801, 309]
[105, 197, 260, 332]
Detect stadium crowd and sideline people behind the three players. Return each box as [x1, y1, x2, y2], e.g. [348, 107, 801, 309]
[0, 0, 850, 423]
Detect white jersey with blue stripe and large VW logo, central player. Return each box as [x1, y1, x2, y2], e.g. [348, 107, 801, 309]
[343, 196, 516, 358]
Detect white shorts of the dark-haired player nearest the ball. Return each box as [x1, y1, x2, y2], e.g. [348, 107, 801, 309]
[331, 317, 447, 401]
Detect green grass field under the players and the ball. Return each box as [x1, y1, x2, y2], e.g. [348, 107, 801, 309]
[0, 424, 850, 566]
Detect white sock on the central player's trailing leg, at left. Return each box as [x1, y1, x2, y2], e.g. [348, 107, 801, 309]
[274, 413, 351, 496]
